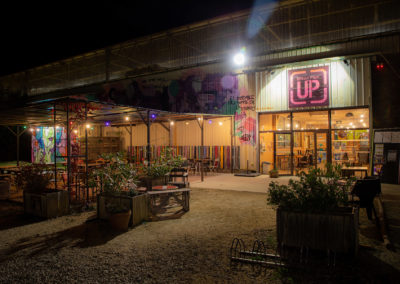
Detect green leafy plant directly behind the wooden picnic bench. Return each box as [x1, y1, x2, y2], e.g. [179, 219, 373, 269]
[140, 148, 184, 190]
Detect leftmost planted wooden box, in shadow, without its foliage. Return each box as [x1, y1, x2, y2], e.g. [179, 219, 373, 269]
[24, 190, 69, 219]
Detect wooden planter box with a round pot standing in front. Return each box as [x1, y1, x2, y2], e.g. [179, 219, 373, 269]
[97, 193, 148, 227]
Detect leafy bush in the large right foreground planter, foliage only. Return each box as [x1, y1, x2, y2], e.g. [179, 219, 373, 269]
[267, 164, 353, 212]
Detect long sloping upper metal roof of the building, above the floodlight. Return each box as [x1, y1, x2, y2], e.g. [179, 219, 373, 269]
[0, 0, 400, 100]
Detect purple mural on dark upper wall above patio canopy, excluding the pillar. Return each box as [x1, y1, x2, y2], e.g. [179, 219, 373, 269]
[96, 68, 239, 114]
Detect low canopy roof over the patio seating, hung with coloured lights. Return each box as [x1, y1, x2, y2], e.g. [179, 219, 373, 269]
[0, 98, 231, 126]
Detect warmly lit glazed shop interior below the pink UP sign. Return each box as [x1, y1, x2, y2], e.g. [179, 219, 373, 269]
[259, 108, 370, 175]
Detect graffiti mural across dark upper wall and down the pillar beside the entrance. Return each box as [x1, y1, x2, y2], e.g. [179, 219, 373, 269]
[90, 68, 256, 145]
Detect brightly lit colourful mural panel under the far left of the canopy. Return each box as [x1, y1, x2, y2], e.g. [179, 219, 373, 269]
[32, 127, 67, 164]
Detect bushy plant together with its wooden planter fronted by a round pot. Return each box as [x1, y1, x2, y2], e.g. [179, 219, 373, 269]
[90, 153, 147, 230]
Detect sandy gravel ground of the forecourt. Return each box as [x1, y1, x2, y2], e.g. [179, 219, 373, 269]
[0, 189, 399, 283]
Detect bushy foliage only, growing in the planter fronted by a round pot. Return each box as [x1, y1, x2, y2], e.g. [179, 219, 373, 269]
[89, 152, 138, 196]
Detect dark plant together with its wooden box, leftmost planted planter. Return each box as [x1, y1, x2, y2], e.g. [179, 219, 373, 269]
[18, 164, 69, 218]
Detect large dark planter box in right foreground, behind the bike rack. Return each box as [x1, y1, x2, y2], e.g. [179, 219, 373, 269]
[276, 207, 358, 255]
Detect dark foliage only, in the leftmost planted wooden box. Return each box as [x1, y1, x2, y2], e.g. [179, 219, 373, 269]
[18, 164, 53, 193]
